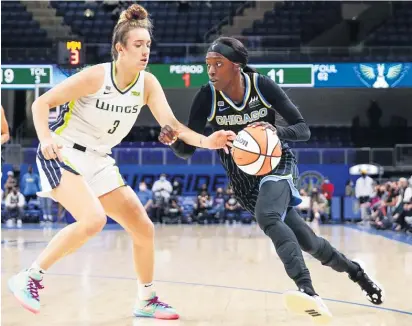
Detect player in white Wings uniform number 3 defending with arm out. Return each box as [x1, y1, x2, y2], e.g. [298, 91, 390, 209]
[8, 4, 235, 319]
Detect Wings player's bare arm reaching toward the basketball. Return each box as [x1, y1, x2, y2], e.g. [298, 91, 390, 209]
[145, 73, 236, 152]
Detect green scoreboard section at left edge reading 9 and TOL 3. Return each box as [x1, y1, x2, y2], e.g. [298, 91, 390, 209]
[0, 65, 53, 89]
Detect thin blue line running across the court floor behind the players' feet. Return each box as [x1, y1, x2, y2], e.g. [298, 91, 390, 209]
[1, 271, 412, 316]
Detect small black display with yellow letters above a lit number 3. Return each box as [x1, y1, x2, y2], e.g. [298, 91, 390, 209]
[57, 40, 86, 68]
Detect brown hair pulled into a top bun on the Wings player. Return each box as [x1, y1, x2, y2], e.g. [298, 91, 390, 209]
[112, 4, 153, 60]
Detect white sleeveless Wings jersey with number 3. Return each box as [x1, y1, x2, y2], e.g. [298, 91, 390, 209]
[50, 62, 144, 154]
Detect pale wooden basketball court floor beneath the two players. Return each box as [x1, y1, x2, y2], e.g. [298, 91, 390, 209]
[1, 225, 412, 326]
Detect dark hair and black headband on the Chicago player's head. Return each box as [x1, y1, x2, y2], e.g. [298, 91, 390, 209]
[208, 36, 256, 72]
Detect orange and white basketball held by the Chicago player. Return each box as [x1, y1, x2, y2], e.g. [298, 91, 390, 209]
[232, 127, 282, 175]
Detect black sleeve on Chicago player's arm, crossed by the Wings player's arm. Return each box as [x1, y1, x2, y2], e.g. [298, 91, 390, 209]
[170, 85, 212, 160]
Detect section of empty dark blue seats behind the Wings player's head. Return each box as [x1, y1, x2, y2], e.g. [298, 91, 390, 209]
[51, 1, 245, 62]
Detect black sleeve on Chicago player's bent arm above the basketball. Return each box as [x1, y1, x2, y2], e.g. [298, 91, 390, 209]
[258, 75, 310, 141]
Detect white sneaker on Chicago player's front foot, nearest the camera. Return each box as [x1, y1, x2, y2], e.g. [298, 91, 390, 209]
[283, 291, 332, 325]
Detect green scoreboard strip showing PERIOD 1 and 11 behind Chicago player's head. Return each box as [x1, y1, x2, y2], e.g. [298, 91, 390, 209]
[148, 64, 315, 88]
